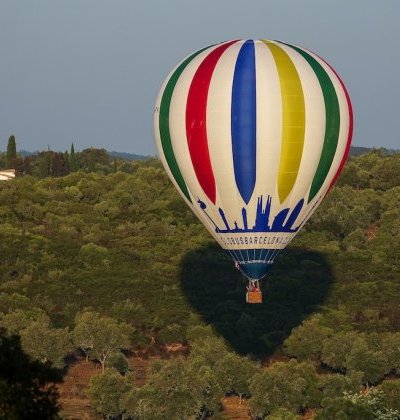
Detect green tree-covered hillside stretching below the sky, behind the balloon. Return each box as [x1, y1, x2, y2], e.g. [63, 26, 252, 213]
[0, 143, 400, 420]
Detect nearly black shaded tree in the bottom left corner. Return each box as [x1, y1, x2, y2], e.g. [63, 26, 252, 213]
[0, 328, 62, 420]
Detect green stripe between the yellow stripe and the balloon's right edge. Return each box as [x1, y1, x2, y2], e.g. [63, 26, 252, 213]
[287, 44, 340, 202]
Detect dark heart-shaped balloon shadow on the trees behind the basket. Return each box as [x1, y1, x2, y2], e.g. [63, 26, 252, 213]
[180, 244, 333, 357]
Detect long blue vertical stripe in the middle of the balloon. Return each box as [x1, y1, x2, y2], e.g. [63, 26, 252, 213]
[231, 41, 257, 204]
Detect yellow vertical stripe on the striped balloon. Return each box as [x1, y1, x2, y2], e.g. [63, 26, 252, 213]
[263, 40, 306, 203]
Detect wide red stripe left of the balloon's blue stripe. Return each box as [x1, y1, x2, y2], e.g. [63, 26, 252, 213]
[186, 41, 237, 204]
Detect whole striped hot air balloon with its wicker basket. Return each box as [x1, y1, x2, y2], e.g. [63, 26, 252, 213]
[154, 40, 353, 302]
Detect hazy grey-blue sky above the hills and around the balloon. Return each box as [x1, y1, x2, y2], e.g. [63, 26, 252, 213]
[0, 0, 400, 154]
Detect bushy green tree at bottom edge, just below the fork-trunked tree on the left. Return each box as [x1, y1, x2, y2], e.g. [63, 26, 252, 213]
[87, 369, 134, 419]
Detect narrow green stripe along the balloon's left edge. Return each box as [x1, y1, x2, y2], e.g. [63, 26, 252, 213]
[158, 47, 209, 202]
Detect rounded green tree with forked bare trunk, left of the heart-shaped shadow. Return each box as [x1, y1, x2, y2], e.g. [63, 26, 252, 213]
[73, 312, 134, 372]
